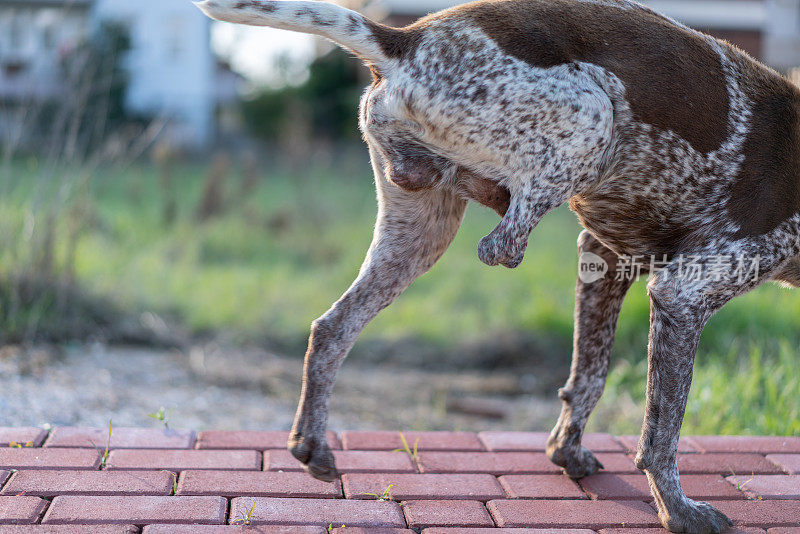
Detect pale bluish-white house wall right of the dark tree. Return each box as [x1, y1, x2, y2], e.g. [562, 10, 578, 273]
[94, 0, 216, 147]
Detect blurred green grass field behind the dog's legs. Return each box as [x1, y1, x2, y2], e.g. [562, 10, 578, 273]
[0, 156, 800, 434]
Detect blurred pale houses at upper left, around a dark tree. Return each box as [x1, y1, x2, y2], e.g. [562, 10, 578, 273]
[0, 0, 241, 148]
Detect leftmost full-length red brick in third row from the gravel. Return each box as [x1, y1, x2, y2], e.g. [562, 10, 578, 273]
[0, 470, 173, 497]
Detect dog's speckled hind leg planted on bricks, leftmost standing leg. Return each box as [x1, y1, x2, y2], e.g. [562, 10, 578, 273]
[288, 151, 466, 486]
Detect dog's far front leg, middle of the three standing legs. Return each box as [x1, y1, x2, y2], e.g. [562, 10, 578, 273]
[547, 230, 633, 478]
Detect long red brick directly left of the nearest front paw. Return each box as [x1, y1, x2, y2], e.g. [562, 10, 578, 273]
[486, 500, 660, 528]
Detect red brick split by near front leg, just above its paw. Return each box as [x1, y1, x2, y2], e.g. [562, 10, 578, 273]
[580, 473, 744, 501]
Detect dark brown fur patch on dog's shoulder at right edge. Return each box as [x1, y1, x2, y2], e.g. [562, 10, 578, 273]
[727, 55, 800, 238]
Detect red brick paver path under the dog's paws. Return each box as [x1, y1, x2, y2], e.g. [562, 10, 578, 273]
[0, 427, 800, 534]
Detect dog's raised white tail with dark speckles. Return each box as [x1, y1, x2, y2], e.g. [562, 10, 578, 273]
[195, 0, 400, 64]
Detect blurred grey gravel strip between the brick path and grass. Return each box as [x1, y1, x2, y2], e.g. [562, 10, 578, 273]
[0, 344, 560, 431]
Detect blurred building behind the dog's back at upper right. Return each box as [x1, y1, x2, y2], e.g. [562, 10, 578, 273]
[379, 0, 800, 71]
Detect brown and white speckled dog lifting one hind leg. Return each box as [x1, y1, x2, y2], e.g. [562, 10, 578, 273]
[198, 0, 800, 533]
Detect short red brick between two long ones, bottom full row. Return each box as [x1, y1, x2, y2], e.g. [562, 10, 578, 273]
[403, 501, 494, 528]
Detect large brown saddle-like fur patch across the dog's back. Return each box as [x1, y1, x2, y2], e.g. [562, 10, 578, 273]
[450, 0, 730, 153]
